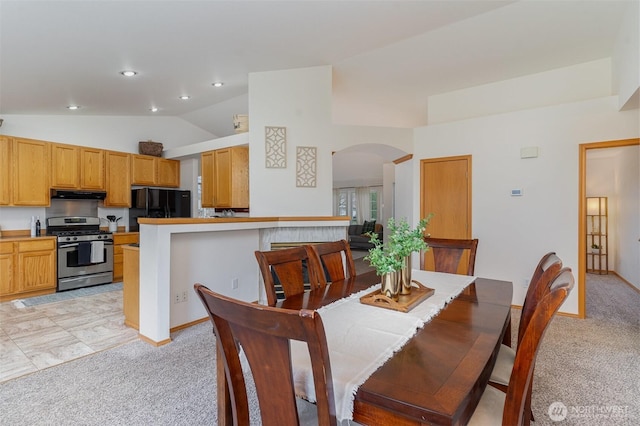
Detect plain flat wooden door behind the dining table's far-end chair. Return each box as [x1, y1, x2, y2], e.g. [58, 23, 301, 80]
[420, 155, 472, 270]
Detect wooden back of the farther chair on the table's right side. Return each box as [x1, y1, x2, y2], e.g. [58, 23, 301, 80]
[518, 252, 562, 343]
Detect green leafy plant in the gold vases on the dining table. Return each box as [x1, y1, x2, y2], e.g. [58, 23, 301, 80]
[364, 214, 433, 275]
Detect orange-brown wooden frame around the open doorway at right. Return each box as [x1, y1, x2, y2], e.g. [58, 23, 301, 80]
[578, 138, 640, 318]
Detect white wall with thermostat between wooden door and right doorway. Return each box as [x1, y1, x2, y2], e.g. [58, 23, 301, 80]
[413, 97, 640, 314]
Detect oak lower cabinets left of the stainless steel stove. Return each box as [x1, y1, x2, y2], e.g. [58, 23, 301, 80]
[0, 237, 57, 301]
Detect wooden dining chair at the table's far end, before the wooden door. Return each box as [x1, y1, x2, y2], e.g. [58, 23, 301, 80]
[420, 237, 478, 275]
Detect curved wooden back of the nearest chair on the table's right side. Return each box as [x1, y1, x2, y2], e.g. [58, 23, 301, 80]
[502, 268, 574, 426]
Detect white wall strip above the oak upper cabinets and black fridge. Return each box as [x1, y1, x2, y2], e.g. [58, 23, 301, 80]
[1, 112, 215, 153]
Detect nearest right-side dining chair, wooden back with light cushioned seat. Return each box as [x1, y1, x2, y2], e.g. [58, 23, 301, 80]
[468, 268, 574, 426]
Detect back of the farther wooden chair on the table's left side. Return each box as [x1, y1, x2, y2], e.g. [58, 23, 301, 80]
[310, 240, 356, 284]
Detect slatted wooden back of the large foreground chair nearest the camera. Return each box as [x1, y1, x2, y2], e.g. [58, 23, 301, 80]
[194, 284, 337, 426]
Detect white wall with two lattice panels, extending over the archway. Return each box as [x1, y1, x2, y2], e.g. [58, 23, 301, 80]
[249, 66, 412, 216]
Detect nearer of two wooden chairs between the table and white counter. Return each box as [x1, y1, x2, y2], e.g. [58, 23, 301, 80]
[255, 245, 326, 306]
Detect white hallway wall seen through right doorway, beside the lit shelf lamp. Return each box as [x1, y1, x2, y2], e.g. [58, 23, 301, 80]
[614, 146, 640, 289]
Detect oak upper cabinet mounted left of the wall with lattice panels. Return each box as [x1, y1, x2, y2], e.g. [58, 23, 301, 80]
[200, 146, 249, 208]
